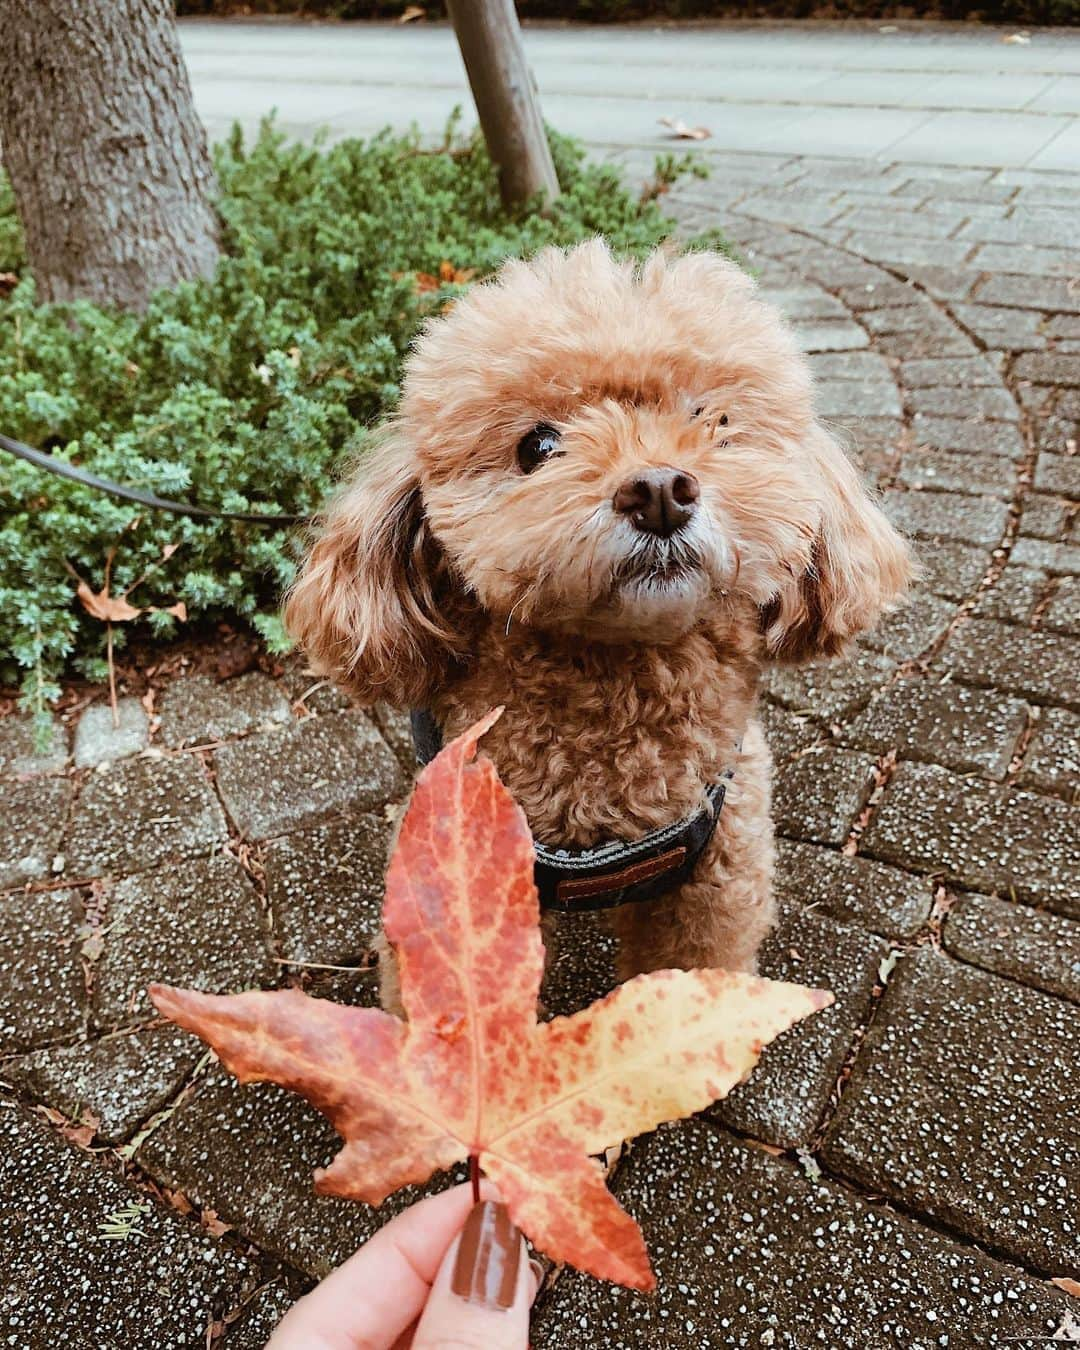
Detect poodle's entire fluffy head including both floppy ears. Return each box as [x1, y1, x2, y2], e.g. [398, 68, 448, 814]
[286, 240, 910, 702]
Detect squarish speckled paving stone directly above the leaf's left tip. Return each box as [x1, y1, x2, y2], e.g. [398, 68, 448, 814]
[92, 855, 279, 1026]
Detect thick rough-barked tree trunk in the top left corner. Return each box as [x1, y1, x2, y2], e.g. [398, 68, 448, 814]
[0, 0, 219, 309]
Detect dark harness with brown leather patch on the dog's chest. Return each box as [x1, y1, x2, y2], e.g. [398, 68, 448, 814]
[410, 709, 738, 914]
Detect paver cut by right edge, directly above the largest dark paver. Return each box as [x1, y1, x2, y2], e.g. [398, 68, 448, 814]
[941, 895, 1080, 1002]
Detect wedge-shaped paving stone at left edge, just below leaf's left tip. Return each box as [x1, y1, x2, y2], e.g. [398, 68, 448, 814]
[3, 1025, 203, 1143]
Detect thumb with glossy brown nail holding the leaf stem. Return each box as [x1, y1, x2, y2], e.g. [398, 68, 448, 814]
[412, 1200, 537, 1350]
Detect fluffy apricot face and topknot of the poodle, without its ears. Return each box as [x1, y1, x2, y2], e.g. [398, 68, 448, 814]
[401, 243, 821, 643]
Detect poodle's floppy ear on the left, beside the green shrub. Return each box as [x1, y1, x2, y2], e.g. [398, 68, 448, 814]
[285, 432, 466, 707]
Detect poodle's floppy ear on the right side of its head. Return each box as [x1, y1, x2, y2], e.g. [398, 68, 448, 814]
[763, 424, 913, 662]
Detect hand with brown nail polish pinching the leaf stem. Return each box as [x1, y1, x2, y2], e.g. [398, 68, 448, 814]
[266, 1184, 540, 1350]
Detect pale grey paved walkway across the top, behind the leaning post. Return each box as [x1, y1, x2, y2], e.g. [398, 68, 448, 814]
[181, 22, 1080, 170]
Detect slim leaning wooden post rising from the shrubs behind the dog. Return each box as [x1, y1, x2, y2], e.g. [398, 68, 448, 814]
[447, 0, 559, 207]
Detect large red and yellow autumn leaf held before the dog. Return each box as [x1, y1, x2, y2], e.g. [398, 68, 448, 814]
[150, 710, 832, 1289]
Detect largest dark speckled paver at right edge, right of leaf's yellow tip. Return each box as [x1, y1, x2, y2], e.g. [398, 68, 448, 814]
[824, 949, 1080, 1272]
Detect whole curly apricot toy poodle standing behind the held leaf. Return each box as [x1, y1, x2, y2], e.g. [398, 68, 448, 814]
[286, 239, 910, 1003]
